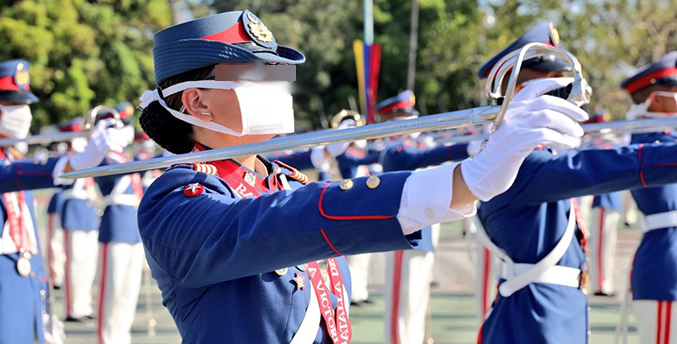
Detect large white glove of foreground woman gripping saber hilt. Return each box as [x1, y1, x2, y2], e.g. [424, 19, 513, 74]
[461, 78, 588, 201]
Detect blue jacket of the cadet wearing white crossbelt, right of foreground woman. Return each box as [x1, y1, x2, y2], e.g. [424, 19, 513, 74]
[478, 144, 677, 344]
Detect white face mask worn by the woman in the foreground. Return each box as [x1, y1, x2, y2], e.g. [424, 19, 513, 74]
[141, 80, 294, 136]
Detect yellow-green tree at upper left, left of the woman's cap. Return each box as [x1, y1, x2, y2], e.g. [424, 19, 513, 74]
[0, 0, 172, 131]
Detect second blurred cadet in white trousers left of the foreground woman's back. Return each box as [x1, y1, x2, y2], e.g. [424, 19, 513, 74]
[59, 117, 99, 322]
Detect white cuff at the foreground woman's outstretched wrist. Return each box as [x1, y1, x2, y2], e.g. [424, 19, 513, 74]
[397, 162, 476, 235]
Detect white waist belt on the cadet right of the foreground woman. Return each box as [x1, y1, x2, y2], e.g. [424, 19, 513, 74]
[501, 262, 582, 288]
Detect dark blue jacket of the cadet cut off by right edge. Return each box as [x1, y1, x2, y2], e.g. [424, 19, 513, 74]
[631, 133, 677, 301]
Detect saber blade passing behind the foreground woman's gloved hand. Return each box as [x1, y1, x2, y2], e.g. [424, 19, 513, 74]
[435, 117, 677, 144]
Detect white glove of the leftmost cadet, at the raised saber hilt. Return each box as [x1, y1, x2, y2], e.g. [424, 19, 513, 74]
[70, 118, 127, 170]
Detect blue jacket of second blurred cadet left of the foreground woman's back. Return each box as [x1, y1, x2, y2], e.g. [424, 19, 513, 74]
[61, 180, 99, 232]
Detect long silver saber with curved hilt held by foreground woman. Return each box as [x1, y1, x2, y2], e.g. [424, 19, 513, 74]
[61, 43, 591, 179]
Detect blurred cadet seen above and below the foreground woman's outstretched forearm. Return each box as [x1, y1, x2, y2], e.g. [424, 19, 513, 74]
[376, 90, 478, 344]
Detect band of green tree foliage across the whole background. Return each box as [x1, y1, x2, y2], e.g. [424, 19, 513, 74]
[0, 0, 677, 128]
